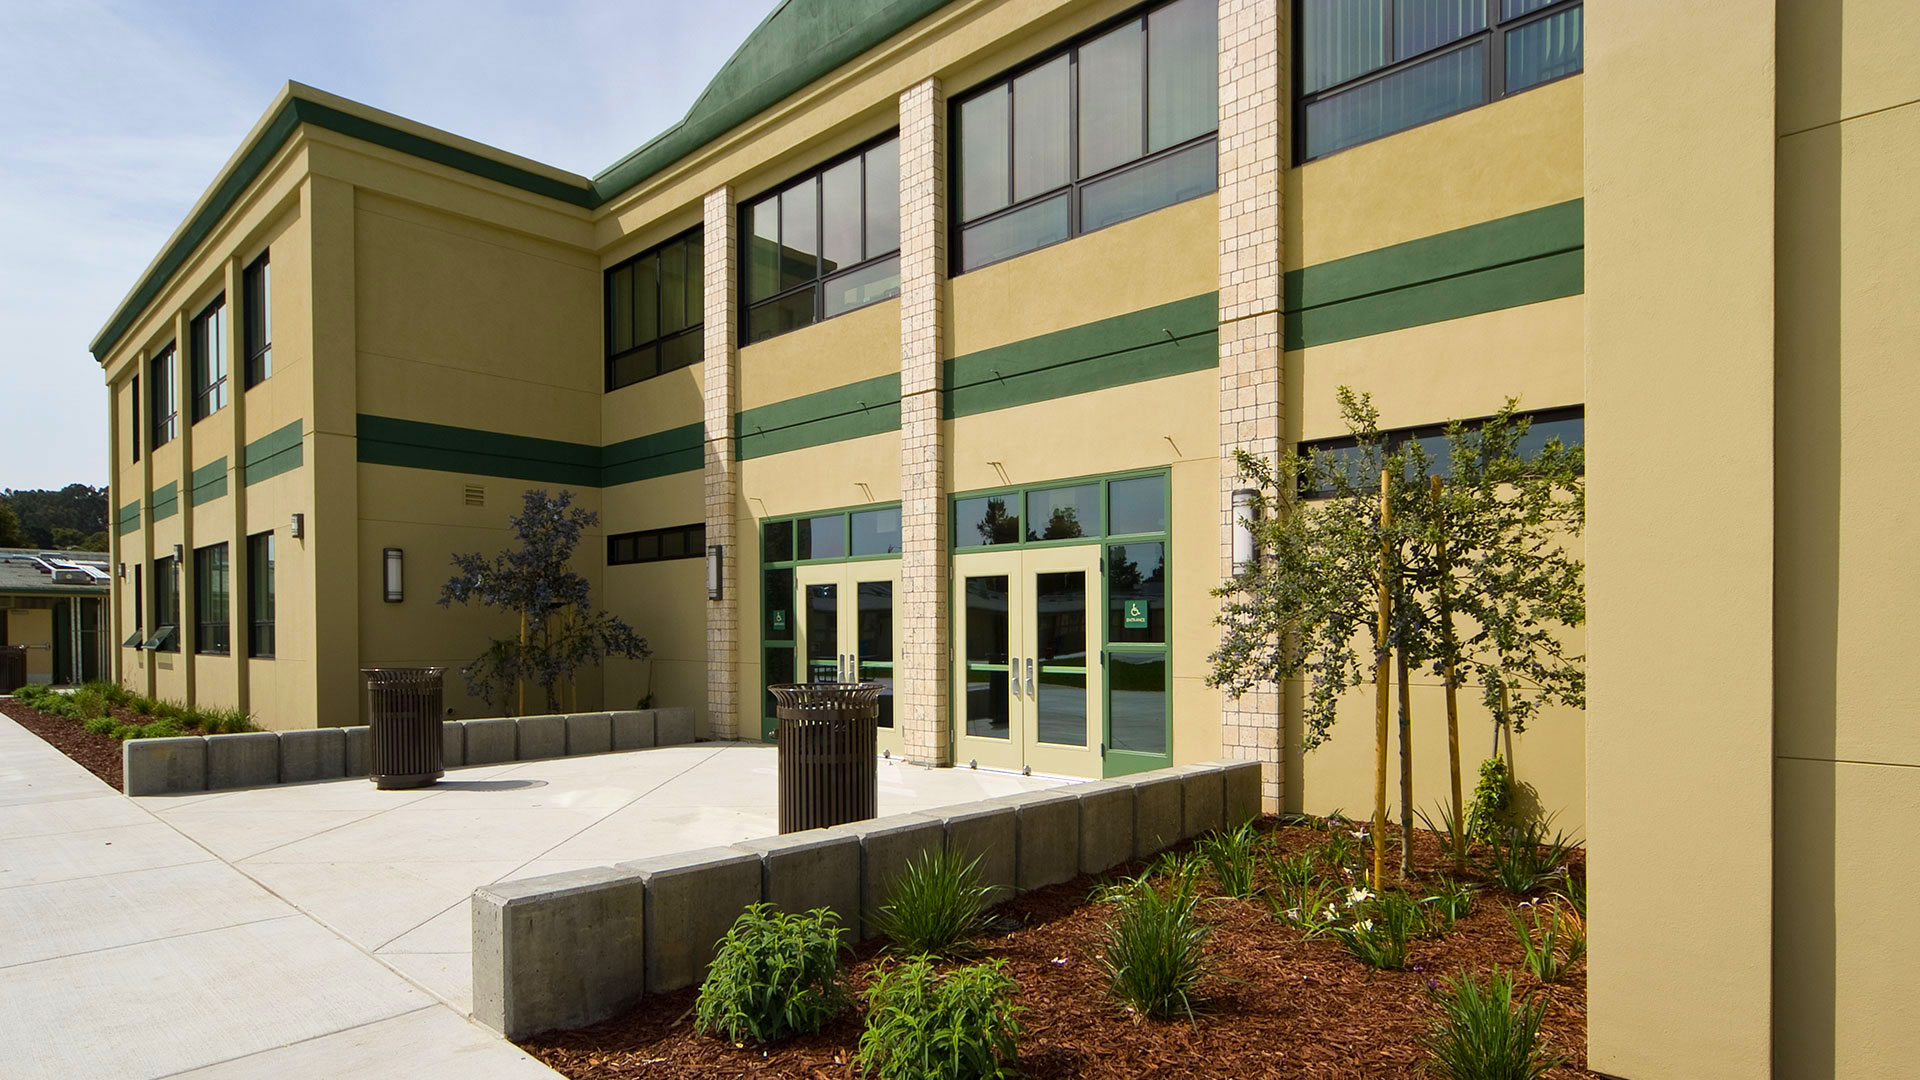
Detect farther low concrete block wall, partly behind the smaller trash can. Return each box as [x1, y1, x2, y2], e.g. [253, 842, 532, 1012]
[121, 707, 693, 796]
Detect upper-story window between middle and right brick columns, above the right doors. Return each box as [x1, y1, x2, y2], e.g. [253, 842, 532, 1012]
[952, 0, 1219, 271]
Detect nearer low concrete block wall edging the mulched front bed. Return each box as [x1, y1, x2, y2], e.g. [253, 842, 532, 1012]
[472, 761, 1261, 1038]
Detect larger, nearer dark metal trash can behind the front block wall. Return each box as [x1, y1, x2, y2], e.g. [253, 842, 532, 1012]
[768, 682, 883, 832]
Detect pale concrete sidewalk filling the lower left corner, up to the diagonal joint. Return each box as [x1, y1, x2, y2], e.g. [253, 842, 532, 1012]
[0, 717, 553, 1080]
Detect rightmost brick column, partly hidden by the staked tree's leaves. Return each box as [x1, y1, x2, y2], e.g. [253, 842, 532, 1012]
[1219, 0, 1284, 813]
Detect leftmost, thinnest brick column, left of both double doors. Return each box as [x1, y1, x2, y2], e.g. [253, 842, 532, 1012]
[703, 186, 741, 738]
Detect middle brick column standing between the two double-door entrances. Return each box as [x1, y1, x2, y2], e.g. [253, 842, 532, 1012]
[895, 79, 952, 765]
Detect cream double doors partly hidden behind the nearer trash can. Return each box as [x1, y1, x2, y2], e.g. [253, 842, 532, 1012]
[793, 559, 906, 757]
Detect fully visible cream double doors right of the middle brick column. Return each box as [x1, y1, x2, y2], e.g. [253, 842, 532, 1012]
[952, 544, 1106, 776]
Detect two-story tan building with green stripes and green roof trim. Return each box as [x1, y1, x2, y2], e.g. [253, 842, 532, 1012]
[92, 0, 1920, 1080]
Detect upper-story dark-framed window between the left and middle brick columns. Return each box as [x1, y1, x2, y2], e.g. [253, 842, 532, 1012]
[739, 133, 900, 344]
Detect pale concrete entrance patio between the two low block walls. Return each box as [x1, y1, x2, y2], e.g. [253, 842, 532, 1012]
[129, 744, 1062, 1015]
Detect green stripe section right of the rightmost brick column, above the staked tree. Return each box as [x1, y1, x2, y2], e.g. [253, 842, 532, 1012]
[1284, 200, 1586, 350]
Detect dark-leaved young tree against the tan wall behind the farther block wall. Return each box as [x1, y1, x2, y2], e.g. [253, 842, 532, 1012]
[440, 490, 651, 711]
